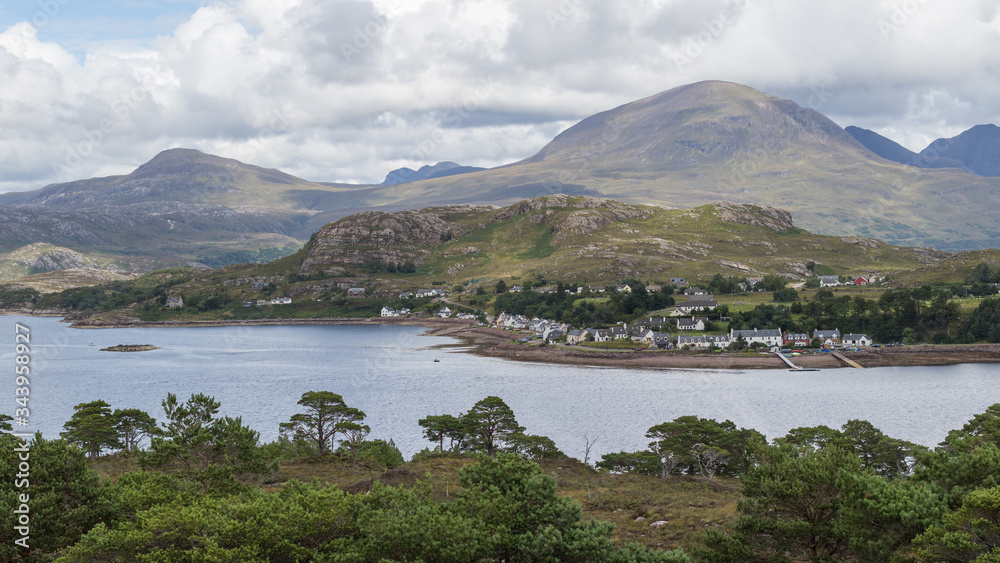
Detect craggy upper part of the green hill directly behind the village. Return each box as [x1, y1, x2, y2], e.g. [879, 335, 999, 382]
[298, 195, 951, 283]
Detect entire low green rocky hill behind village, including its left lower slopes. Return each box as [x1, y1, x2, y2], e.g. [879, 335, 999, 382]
[35, 195, 1000, 320]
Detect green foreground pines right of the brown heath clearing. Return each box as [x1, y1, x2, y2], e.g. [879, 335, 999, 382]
[597, 404, 1000, 563]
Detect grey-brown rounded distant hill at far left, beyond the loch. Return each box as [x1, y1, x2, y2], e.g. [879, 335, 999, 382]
[0, 149, 347, 280]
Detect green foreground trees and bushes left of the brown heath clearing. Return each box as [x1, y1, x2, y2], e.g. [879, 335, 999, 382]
[0, 391, 690, 563]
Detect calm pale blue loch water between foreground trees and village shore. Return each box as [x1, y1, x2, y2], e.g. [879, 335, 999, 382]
[0, 316, 1000, 457]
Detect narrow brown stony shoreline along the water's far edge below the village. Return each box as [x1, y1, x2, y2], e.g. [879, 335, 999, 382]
[46, 315, 1000, 371]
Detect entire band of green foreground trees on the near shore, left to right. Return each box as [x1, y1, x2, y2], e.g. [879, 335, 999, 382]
[0, 391, 1000, 563]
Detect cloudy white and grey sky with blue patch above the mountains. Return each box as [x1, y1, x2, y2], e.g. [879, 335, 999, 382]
[0, 0, 1000, 192]
